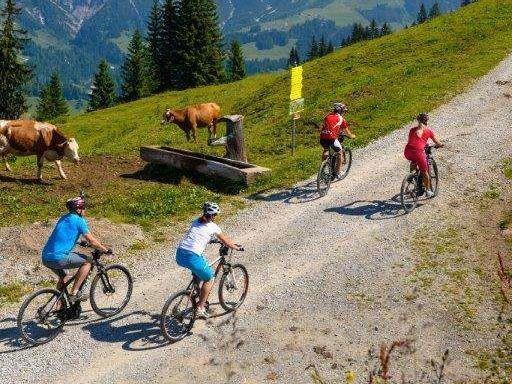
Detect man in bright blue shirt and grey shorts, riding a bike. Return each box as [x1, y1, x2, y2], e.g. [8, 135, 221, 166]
[42, 197, 112, 302]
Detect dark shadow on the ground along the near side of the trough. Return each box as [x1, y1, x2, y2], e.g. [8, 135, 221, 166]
[121, 163, 245, 195]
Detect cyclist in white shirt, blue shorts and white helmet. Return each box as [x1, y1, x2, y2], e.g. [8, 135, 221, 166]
[176, 202, 242, 318]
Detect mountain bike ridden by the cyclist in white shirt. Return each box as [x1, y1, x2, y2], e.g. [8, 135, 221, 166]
[160, 240, 249, 342]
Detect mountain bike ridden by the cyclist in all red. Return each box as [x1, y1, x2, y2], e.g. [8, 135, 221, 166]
[400, 145, 439, 213]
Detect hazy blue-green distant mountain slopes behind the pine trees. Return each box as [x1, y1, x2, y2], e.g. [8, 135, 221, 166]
[0, 0, 460, 99]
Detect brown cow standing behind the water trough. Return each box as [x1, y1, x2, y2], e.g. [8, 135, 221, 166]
[162, 103, 220, 141]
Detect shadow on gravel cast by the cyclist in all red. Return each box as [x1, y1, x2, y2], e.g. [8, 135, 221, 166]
[325, 195, 406, 220]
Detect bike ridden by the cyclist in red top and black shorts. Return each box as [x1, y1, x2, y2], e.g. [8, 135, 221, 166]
[316, 135, 352, 196]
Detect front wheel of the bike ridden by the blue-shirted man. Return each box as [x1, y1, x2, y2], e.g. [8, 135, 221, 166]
[91, 264, 133, 317]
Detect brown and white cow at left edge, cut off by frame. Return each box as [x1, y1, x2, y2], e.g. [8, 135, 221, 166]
[0, 120, 80, 181]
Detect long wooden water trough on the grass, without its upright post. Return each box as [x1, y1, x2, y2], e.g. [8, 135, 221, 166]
[140, 147, 269, 186]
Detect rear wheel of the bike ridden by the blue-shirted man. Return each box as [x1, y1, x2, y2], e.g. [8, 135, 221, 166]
[17, 288, 66, 345]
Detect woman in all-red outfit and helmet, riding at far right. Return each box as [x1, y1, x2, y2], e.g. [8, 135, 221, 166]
[404, 113, 443, 197]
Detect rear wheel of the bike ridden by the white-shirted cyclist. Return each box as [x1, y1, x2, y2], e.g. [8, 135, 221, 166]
[160, 291, 196, 342]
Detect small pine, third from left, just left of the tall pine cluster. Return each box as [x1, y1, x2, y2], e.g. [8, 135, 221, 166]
[87, 59, 116, 111]
